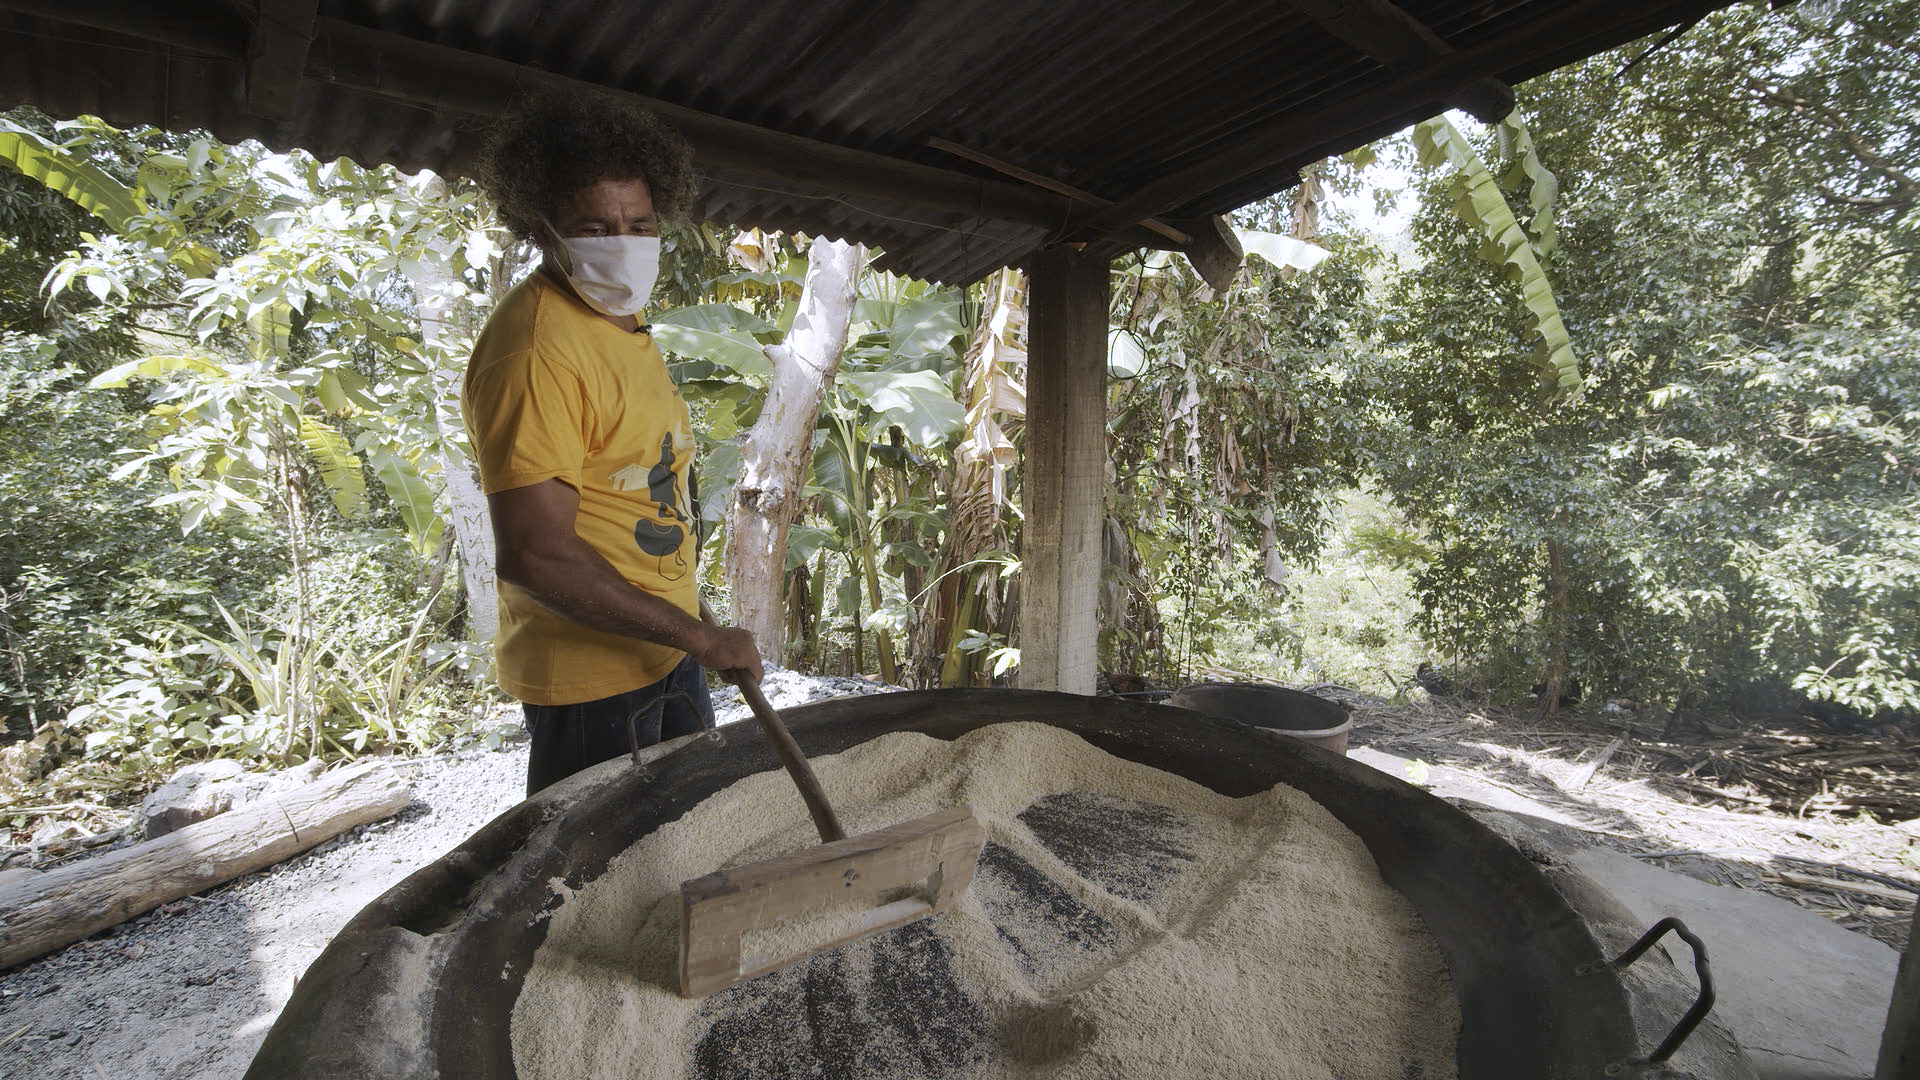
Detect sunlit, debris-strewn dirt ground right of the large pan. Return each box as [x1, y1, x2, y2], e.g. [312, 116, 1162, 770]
[1315, 686, 1920, 949]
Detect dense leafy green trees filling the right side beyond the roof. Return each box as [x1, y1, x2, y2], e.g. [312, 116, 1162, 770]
[1375, 4, 1920, 713]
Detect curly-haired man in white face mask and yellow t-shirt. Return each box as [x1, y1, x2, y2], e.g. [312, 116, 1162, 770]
[463, 98, 760, 794]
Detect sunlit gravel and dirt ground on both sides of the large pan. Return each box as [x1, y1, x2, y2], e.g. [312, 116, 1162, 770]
[0, 673, 1920, 1080]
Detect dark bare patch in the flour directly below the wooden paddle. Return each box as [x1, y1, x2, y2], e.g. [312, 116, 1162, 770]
[691, 920, 993, 1080]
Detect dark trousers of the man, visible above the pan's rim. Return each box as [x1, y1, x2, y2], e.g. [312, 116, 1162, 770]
[520, 645, 714, 796]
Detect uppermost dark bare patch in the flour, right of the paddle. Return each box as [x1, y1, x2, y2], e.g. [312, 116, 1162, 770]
[1020, 780, 1194, 903]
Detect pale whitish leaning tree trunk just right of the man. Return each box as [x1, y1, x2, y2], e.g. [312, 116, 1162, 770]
[722, 238, 866, 663]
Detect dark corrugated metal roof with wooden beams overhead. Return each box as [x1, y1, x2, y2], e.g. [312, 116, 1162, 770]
[0, 0, 1720, 282]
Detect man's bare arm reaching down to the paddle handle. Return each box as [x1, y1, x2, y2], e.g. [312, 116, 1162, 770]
[488, 480, 760, 682]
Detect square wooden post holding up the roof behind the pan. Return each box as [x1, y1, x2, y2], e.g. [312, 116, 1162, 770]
[1018, 248, 1108, 694]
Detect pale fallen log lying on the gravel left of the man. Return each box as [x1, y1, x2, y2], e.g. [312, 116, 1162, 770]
[0, 763, 411, 970]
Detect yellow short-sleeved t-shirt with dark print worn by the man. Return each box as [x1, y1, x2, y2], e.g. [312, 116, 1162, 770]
[461, 271, 699, 705]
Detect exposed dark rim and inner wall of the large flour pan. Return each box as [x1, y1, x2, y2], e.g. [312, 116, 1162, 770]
[248, 690, 1697, 1080]
